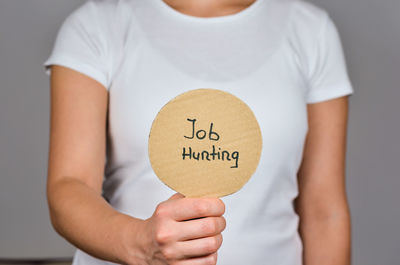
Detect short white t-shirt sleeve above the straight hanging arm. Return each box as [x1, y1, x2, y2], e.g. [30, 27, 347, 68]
[306, 13, 354, 103]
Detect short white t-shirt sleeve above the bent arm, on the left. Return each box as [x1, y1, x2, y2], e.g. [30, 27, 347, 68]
[43, 1, 110, 89]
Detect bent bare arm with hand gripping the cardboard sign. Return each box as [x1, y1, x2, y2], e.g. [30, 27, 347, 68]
[47, 66, 225, 265]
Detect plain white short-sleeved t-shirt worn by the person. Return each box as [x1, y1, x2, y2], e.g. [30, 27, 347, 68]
[45, 0, 353, 265]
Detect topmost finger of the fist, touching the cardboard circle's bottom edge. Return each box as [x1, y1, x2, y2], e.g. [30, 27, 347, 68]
[165, 195, 225, 221]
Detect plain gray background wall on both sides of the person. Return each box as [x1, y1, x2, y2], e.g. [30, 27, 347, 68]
[0, 0, 400, 265]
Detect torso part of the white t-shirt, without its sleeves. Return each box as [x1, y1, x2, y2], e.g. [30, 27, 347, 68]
[69, 0, 332, 265]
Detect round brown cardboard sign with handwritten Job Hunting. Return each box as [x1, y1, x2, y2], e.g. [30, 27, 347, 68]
[148, 88, 262, 197]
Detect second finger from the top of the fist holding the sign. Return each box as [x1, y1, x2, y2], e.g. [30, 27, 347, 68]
[177, 216, 226, 241]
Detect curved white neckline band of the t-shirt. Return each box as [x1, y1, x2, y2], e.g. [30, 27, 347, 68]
[153, 0, 264, 23]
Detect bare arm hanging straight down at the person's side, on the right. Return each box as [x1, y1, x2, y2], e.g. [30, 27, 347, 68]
[295, 97, 351, 265]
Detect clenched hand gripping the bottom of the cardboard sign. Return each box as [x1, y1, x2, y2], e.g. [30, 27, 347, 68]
[144, 193, 226, 265]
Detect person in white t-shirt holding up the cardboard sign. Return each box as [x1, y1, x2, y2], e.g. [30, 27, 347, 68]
[44, 0, 354, 265]
